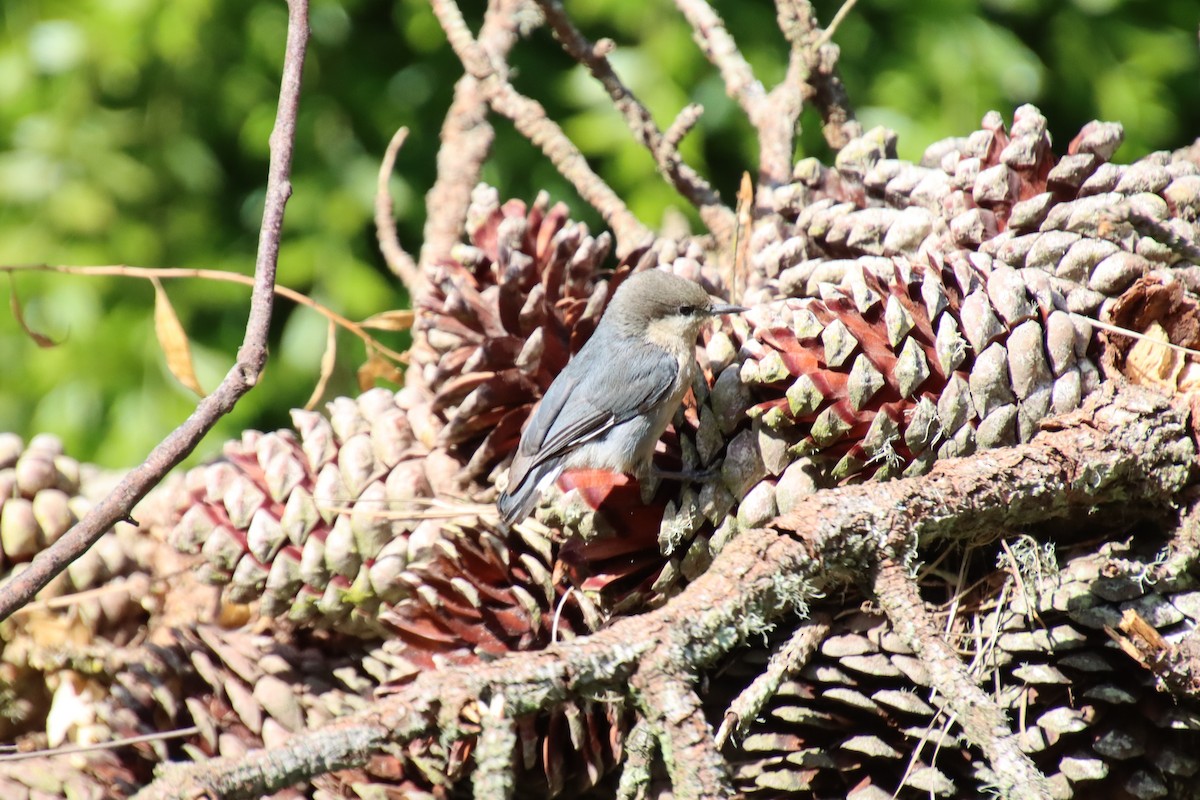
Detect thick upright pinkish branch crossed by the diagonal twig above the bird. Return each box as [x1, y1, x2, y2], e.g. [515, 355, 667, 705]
[420, 0, 524, 272]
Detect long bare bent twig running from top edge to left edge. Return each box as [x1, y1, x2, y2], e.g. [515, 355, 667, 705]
[0, 0, 308, 619]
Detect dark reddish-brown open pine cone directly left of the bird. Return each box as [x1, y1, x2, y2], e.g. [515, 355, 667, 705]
[409, 186, 612, 476]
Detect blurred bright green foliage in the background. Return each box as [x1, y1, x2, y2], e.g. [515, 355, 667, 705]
[0, 0, 1200, 467]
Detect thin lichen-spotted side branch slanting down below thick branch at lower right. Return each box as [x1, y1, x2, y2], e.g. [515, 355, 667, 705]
[874, 556, 1052, 800]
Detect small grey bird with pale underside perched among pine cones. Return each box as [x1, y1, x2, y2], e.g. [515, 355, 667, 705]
[497, 269, 746, 525]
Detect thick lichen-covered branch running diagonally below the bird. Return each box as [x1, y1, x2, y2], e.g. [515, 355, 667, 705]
[131, 386, 1195, 800]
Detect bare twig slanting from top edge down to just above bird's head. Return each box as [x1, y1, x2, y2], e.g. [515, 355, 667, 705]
[432, 0, 654, 255]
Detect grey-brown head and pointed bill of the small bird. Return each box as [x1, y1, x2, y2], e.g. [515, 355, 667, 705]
[605, 270, 746, 353]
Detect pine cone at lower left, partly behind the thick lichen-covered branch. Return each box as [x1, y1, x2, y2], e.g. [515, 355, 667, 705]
[94, 625, 446, 799]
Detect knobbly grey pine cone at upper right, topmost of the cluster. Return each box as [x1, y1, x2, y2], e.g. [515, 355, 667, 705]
[751, 106, 1200, 314]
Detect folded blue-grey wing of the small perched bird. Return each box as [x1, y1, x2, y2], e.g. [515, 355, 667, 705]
[509, 340, 679, 486]
